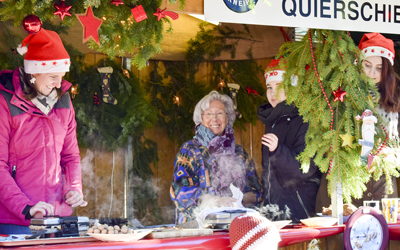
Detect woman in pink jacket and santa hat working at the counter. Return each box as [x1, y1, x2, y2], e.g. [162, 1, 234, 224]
[0, 29, 87, 234]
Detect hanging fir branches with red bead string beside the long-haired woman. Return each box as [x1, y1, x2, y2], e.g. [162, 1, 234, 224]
[279, 29, 399, 202]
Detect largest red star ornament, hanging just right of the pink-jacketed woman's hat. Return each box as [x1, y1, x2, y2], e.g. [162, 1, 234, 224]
[75, 6, 103, 46]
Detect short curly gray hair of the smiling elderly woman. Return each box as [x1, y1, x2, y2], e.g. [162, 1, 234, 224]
[193, 90, 236, 127]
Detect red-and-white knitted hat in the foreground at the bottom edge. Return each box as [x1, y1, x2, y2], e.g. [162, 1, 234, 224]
[229, 213, 281, 250]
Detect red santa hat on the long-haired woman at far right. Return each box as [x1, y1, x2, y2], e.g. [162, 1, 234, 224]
[358, 33, 395, 65]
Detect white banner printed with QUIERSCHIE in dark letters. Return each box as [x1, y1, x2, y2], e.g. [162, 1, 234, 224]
[204, 0, 400, 34]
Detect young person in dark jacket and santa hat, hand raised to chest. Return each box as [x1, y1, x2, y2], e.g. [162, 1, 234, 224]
[257, 60, 321, 221]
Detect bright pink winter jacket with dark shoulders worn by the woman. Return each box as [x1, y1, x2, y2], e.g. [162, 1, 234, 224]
[0, 69, 82, 226]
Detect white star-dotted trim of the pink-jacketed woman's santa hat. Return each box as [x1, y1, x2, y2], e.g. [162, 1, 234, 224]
[24, 58, 71, 74]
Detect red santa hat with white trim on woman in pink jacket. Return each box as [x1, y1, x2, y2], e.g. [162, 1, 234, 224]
[17, 28, 71, 74]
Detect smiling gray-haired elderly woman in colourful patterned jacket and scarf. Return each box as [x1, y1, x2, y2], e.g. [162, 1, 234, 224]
[170, 91, 261, 224]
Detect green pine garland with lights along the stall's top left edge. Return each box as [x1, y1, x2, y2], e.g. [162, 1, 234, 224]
[0, 0, 185, 69]
